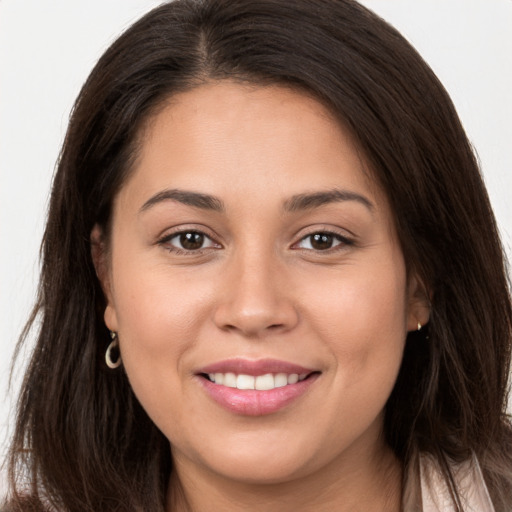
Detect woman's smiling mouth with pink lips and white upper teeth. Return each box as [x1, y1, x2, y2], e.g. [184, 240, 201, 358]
[196, 359, 321, 416]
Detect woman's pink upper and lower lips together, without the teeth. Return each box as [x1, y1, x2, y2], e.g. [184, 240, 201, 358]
[196, 358, 320, 416]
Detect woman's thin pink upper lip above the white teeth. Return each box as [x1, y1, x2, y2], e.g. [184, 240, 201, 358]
[196, 358, 316, 377]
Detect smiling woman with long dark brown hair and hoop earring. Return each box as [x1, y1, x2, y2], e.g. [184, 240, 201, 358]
[4, 0, 512, 511]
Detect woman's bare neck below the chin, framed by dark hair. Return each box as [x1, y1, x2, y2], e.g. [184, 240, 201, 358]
[167, 434, 402, 512]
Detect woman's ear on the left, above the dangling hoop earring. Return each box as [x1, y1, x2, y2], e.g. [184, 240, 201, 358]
[90, 224, 118, 332]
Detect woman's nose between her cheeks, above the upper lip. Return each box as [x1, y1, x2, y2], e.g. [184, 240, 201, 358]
[214, 247, 299, 338]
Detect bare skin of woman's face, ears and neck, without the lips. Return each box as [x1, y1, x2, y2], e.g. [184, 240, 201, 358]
[92, 81, 428, 511]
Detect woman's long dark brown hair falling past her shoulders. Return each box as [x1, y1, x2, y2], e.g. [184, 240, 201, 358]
[5, 0, 512, 512]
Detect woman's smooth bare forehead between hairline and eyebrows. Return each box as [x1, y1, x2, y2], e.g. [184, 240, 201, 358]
[118, 81, 381, 212]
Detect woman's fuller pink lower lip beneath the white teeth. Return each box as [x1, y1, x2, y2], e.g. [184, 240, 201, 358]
[198, 374, 319, 416]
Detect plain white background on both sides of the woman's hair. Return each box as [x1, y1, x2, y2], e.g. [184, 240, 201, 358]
[0, 0, 512, 496]
